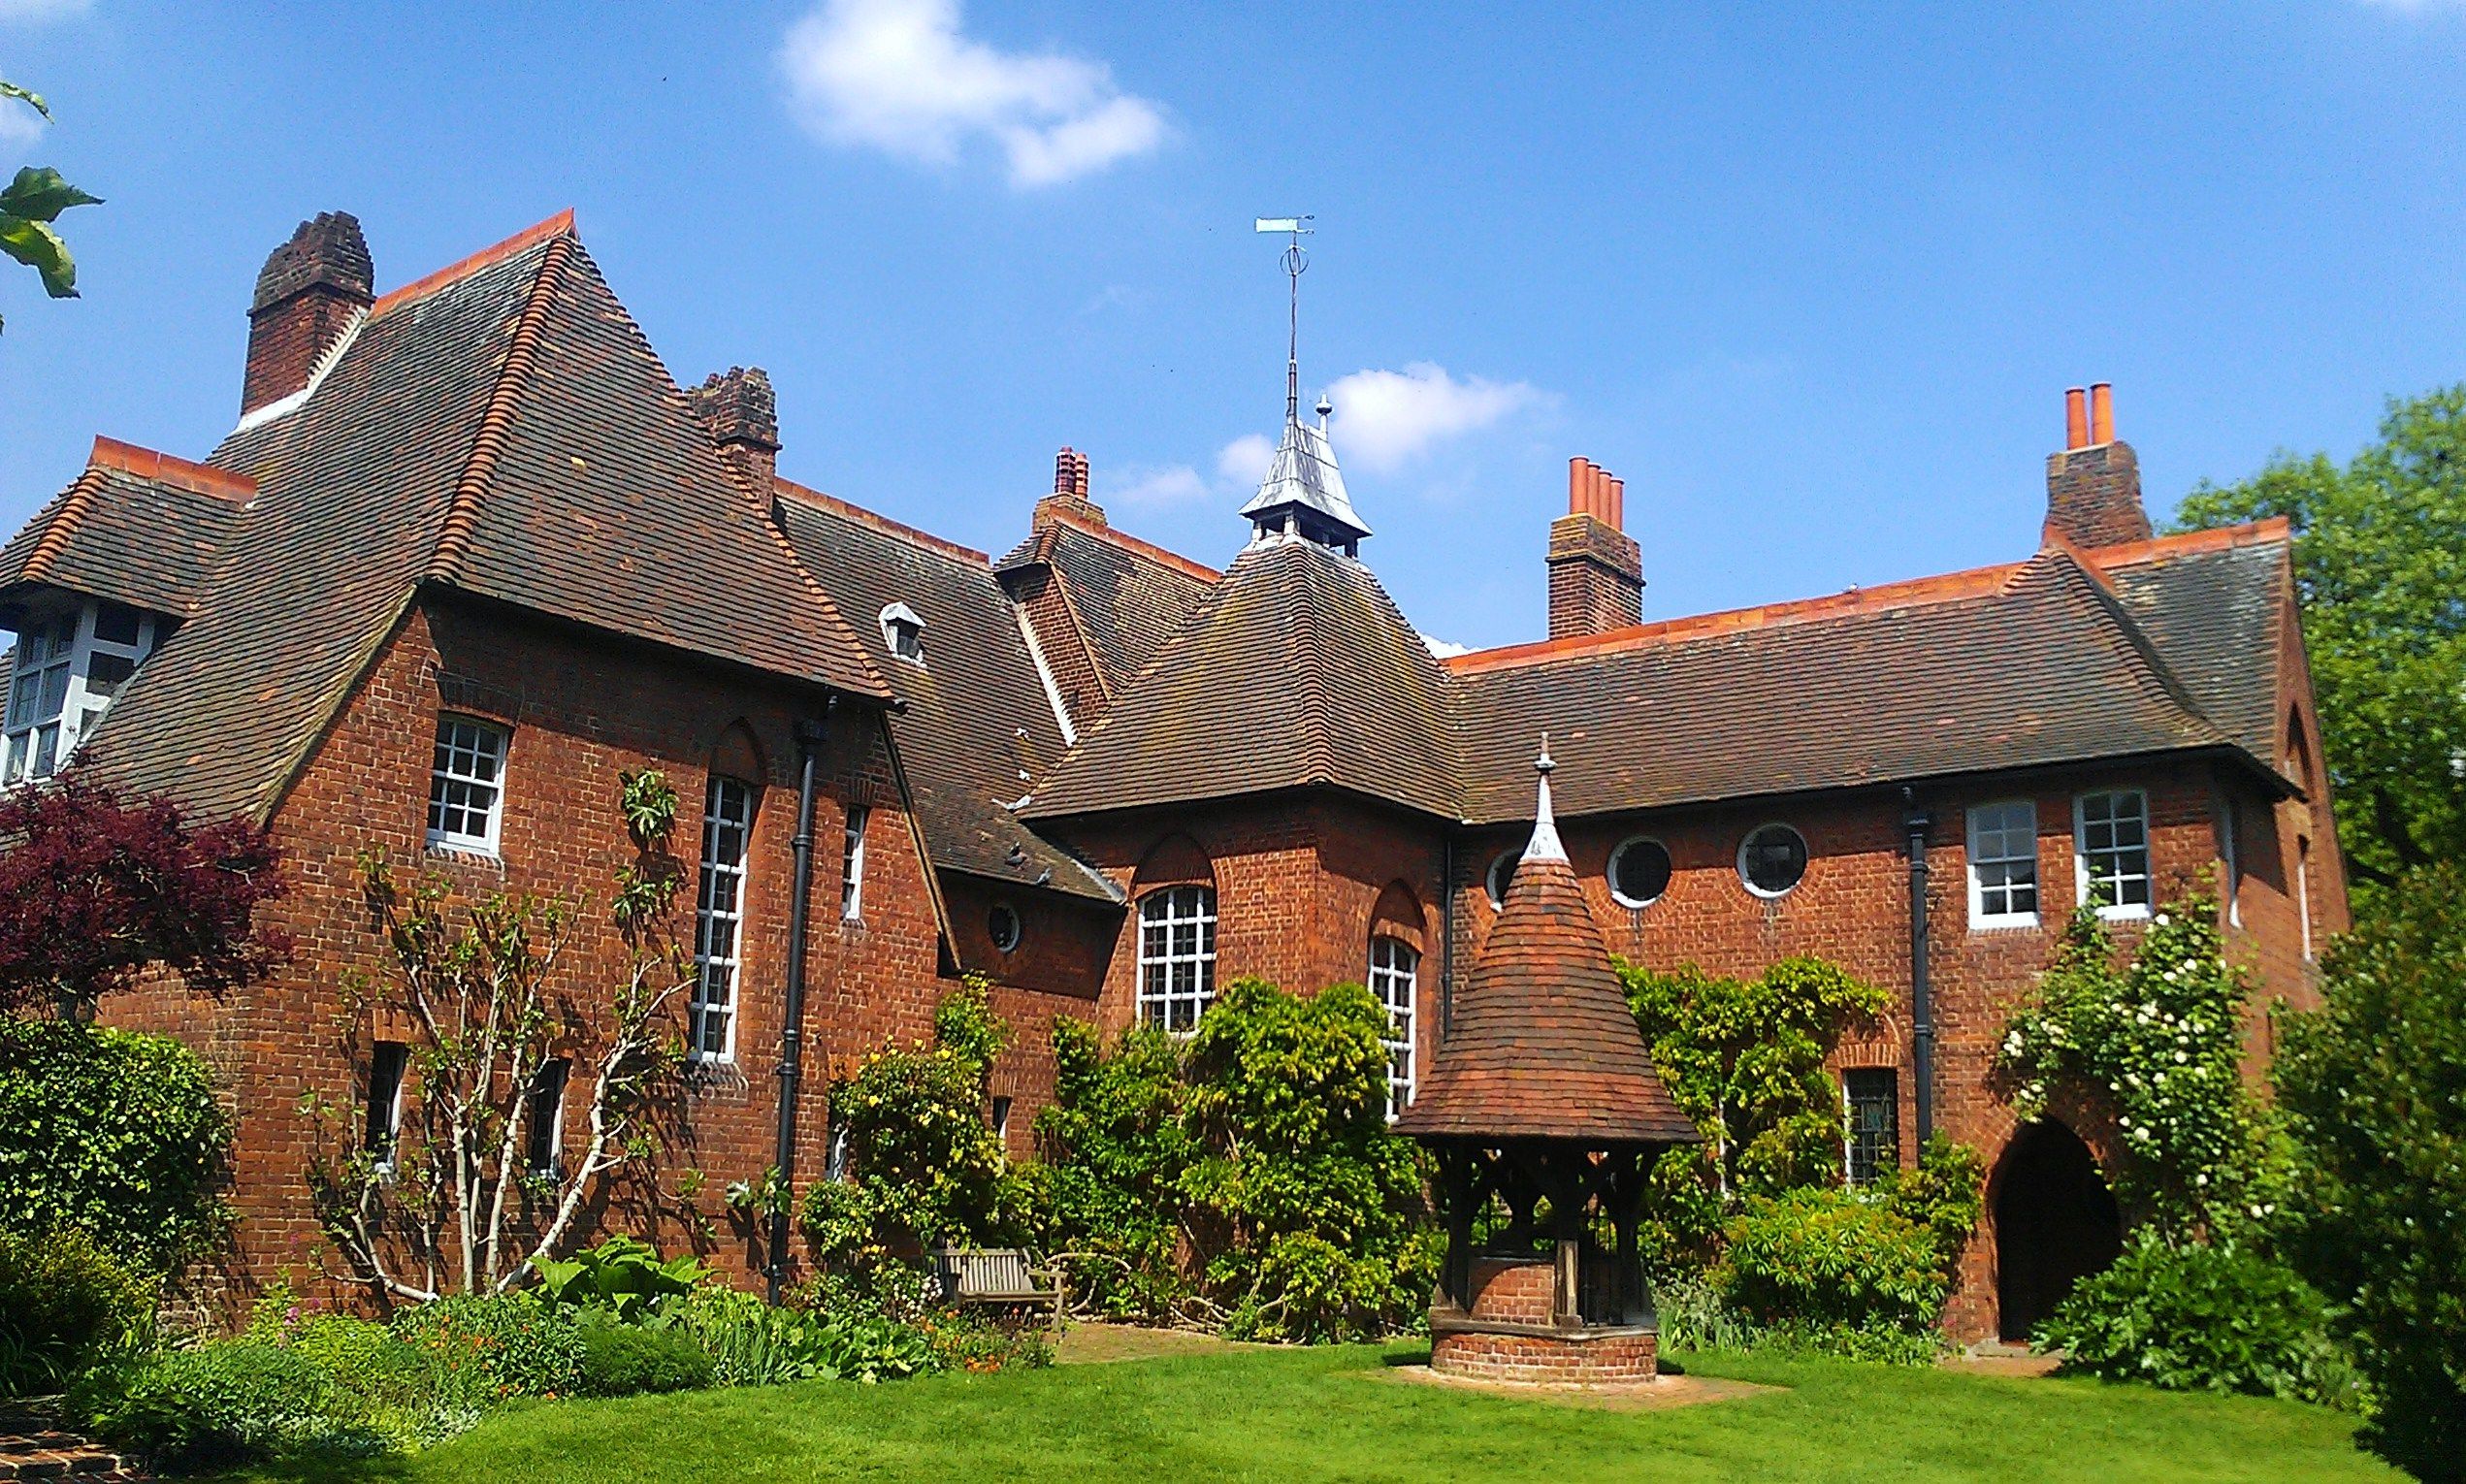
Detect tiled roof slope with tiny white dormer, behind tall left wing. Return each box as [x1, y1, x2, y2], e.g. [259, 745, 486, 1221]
[777, 481, 1119, 902]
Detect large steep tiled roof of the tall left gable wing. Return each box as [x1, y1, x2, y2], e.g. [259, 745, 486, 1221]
[62, 214, 888, 814]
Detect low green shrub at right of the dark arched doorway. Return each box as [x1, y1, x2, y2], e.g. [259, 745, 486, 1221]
[2032, 1230, 2355, 1405]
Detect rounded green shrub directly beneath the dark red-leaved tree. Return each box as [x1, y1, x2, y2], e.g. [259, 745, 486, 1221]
[0, 1016, 232, 1272]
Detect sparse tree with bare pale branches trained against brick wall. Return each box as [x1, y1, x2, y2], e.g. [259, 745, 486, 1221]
[301, 771, 696, 1302]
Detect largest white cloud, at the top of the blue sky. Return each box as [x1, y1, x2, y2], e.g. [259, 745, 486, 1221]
[789, 0, 1169, 187]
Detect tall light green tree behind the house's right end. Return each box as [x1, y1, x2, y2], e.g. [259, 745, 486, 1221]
[2178, 384, 2466, 887]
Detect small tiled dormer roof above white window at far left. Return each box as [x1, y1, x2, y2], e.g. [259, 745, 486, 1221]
[0, 438, 256, 619]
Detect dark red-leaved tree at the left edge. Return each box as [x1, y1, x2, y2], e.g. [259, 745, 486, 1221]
[0, 774, 288, 1016]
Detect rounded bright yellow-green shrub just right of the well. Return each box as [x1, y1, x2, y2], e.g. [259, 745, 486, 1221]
[1716, 1191, 1948, 1337]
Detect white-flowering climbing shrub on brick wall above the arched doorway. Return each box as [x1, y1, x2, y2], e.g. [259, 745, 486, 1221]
[2000, 895, 2274, 1235]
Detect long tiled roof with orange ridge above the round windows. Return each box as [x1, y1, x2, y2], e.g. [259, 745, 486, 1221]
[1447, 532, 2276, 821]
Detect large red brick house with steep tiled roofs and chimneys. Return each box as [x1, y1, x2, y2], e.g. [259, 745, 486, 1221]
[0, 214, 2345, 1337]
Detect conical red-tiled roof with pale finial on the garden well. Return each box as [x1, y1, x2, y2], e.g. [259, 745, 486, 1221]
[1396, 752, 1697, 1146]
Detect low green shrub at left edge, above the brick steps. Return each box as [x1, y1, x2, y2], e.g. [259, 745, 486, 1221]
[0, 1228, 155, 1396]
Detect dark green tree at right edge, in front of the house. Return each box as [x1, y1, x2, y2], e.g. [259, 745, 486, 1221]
[2274, 865, 2466, 1479]
